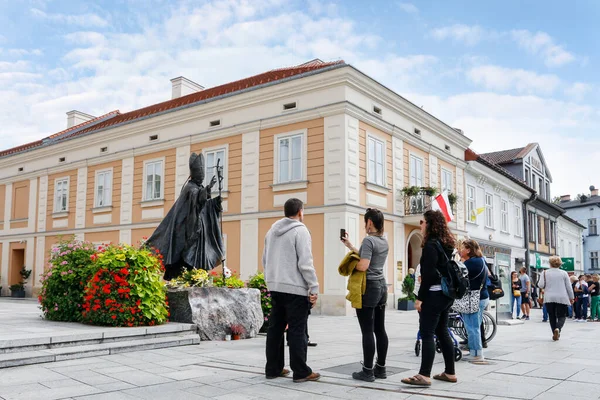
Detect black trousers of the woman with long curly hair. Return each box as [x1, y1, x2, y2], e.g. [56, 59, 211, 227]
[419, 291, 454, 377]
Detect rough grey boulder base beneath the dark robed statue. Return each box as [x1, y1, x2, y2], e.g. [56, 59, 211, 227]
[167, 287, 264, 340]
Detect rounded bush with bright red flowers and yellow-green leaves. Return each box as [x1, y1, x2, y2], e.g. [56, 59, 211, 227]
[82, 245, 169, 326]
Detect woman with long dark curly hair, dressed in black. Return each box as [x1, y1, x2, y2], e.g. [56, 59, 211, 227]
[402, 211, 456, 387]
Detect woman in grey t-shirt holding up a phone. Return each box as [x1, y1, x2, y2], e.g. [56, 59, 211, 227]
[342, 208, 389, 382]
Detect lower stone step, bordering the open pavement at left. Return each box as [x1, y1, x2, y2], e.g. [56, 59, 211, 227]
[0, 331, 200, 368]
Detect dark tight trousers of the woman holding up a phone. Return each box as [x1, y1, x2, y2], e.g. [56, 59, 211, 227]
[356, 280, 389, 369]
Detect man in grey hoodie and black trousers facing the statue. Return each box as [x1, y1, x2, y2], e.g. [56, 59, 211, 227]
[262, 199, 321, 382]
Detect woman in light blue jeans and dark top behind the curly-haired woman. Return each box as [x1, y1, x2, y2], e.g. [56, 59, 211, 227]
[460, 239, 490, 362]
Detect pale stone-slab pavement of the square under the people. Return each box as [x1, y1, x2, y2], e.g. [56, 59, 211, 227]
[0, 302, 600, 400]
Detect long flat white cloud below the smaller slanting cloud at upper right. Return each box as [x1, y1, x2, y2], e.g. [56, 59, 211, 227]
[467, 65, 561, 95]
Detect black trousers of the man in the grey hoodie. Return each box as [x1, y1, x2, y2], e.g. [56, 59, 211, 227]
[265, 292, 312, 379]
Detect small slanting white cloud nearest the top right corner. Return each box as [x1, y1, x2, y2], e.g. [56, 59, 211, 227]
[510, 30, 575, 67]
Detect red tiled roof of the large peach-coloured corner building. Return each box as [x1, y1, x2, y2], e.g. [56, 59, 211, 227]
[0, 59, 347, 157]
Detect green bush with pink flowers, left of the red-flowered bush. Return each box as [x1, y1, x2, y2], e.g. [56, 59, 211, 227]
[38, 240, 95, 322]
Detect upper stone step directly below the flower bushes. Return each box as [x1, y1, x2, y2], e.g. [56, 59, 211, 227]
[0, 323, 197, 355]
